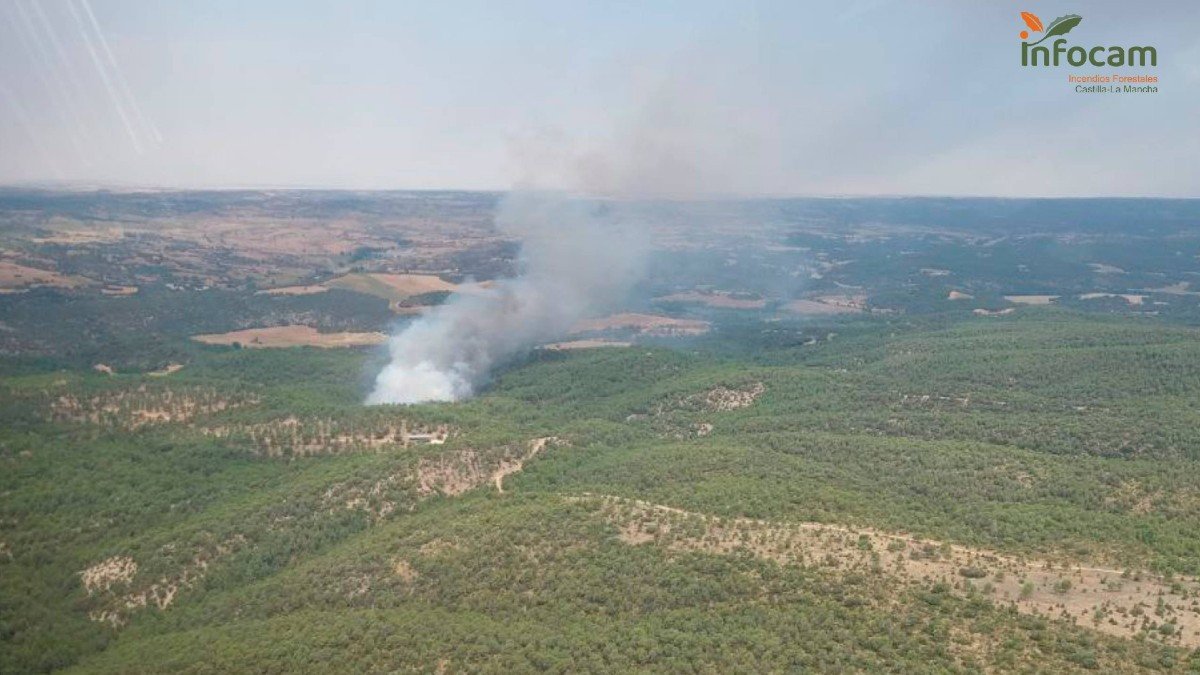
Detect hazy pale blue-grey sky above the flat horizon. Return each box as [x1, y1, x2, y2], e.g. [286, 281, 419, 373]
[0, 0, 1200, 197]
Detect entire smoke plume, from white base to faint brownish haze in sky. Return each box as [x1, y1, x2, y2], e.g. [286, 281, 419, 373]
[367, 53, 761, 404]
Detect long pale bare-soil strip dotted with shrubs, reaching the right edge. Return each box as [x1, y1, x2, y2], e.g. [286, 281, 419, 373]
[595, 496, 1200, 647]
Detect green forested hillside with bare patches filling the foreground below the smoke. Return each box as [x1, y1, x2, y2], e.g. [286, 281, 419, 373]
[7, 307, 1200, 673]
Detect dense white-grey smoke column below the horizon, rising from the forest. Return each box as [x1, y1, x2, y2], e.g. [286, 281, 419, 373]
[367, 193, 647, 404]
